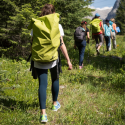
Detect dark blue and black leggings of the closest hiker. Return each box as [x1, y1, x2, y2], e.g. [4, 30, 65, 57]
[36, 66, 59, 109]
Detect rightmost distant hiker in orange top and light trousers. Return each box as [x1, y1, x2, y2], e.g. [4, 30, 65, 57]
[109, 18, 117, 49]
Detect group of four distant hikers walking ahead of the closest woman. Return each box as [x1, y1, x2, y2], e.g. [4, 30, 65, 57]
[74, 13, 119, 69]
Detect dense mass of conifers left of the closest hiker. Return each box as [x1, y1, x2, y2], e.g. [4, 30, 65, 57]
[0, 0, 49, 58]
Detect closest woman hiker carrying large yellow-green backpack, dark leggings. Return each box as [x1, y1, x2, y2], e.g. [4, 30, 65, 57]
[28, 4, 72, 122]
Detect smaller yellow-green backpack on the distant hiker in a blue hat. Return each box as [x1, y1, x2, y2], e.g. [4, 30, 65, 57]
[90, 18, 102, 33]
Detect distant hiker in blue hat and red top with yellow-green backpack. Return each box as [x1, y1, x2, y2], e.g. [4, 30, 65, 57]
[90, 13, 104, 55]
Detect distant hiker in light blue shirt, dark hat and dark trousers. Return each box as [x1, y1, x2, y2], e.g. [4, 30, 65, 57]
[103, 19, 113, 51]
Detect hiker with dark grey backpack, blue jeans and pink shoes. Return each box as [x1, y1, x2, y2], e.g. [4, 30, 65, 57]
[74, 21, 90, 69]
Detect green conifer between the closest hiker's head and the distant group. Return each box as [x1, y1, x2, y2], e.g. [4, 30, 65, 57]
[54, 0, 93, 42]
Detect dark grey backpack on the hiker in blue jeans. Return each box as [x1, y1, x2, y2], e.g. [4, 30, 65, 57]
[74, 26, 86, 42]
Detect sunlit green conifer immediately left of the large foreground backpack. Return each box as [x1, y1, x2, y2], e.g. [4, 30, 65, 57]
[8, 4, 36, 57]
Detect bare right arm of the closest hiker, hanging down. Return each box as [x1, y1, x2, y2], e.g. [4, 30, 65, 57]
[60, 36, 72, 70]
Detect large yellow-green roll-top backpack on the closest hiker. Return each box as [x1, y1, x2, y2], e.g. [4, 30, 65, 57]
[28, 13, 60, 63]
